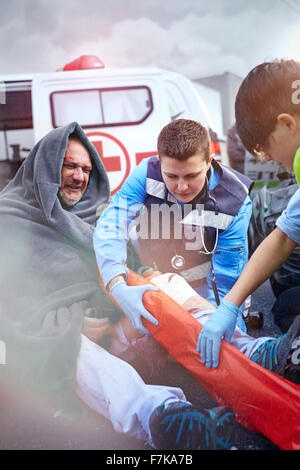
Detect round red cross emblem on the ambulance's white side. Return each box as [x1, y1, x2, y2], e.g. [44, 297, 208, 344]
[86, 132, 130, 195]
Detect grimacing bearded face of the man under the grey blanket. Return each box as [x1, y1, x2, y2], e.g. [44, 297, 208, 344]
[59, 138, 92, 206]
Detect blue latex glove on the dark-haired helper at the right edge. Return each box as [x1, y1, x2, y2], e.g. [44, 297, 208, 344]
[197, 299, 239, 367]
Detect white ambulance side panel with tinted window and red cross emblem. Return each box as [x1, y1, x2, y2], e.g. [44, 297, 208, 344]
[33, 71, 170, 194]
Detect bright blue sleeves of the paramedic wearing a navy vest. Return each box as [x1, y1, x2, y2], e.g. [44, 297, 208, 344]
[94, 159, 252, 331]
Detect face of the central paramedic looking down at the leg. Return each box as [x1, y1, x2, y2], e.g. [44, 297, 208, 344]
[160, 152, 212, 203]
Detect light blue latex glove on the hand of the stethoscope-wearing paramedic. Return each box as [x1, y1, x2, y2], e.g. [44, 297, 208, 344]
[110, 281, 158, 334]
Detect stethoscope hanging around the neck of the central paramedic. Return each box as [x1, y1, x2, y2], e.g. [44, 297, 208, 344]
[169, 175, 220, 305]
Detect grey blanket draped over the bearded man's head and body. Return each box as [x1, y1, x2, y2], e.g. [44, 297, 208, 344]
[0, 122, 121, 404]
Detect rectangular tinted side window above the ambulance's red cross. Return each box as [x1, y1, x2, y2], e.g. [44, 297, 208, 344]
[50, 86, 153, 128]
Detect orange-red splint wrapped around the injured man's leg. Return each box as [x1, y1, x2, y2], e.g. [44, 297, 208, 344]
[128, 271, 300, 450]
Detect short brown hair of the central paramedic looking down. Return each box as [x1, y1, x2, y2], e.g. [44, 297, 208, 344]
[157, 119, 211, 160]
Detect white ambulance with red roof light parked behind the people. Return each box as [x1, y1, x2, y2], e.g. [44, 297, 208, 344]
[0, 55, 224, 194]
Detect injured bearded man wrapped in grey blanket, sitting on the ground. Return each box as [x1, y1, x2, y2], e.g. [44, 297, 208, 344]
[0, 123, 234, 449]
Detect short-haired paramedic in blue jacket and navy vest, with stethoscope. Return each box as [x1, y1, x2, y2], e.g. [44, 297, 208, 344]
[94, 119, 252, 333]
